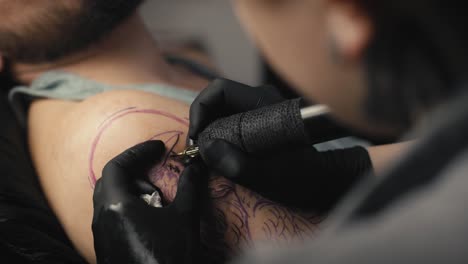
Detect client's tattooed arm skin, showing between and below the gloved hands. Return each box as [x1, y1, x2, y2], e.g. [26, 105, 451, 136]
[149, 157, 320, 262]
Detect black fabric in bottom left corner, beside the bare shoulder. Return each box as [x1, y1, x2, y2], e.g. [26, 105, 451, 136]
[0, 91, 85, 263]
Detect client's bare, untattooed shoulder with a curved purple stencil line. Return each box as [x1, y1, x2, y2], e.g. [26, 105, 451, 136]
[28, 90, 188, 260]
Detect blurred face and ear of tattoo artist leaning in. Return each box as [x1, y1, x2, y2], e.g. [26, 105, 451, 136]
[233, 0, 394, 132]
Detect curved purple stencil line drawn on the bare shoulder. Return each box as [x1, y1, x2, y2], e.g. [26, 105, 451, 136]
[88, 107, 189, 189]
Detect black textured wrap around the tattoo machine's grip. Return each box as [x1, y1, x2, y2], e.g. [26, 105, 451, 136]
[198, 99, 308, 153]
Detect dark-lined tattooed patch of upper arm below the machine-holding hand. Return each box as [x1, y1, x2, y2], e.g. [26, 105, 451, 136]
[210, 178, 321, 252]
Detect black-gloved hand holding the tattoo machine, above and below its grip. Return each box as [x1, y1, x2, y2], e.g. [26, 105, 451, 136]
[189, 80, 372, 211]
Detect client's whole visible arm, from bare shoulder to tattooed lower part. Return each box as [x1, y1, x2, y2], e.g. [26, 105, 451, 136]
[29, 91, 317, 262]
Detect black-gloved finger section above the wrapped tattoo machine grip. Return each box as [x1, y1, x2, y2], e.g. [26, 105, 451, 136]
[189, 79, 285, 140]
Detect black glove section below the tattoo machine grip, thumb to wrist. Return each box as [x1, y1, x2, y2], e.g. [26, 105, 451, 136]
[200, 140, 372, 213]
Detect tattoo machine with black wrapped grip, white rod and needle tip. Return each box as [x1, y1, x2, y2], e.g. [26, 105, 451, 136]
[171, 99, 347, 161]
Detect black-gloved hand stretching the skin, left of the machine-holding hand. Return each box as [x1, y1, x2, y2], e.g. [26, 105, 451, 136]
[92, 141, 203, 264]
